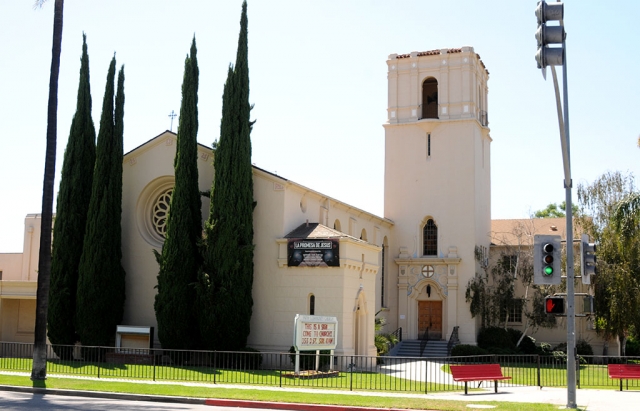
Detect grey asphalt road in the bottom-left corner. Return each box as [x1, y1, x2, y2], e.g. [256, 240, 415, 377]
[0, 391, 266, 411]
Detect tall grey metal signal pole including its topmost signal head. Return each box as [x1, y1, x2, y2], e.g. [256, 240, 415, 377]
[535, 1, 577, 409]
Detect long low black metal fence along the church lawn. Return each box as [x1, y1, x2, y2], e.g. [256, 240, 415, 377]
[0, 342, 640, 393]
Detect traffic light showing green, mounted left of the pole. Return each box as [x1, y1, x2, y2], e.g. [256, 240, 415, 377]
[533, 234, 562, 285]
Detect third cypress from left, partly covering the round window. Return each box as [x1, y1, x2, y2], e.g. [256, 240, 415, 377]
[154, 36, 202, 349]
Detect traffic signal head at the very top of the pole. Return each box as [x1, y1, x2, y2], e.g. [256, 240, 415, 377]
[536, 1, 564, 69]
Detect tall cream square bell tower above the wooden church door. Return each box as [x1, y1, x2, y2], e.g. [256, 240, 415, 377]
[384, 47, 491, 343]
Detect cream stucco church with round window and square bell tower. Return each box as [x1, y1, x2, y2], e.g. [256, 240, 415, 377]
[0, 47, 608, 355]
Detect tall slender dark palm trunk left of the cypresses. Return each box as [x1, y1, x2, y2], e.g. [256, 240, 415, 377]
[31, 0, 64, 380]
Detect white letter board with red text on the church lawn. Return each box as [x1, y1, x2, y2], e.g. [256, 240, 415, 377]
[293, 314, 338, 351]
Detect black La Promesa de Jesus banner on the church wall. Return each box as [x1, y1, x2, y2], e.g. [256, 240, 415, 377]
[287, 238, 340, 267]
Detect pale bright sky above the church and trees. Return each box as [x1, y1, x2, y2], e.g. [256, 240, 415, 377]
[0, 0, 640, 252]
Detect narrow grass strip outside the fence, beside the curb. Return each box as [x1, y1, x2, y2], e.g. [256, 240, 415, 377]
[0, 375, 580, 411]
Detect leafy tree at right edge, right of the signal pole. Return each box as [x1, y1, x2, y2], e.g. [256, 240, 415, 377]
[577, 171, 640, 355]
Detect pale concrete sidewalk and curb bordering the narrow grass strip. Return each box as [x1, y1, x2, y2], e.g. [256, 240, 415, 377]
[0, 373, 640, 411]
